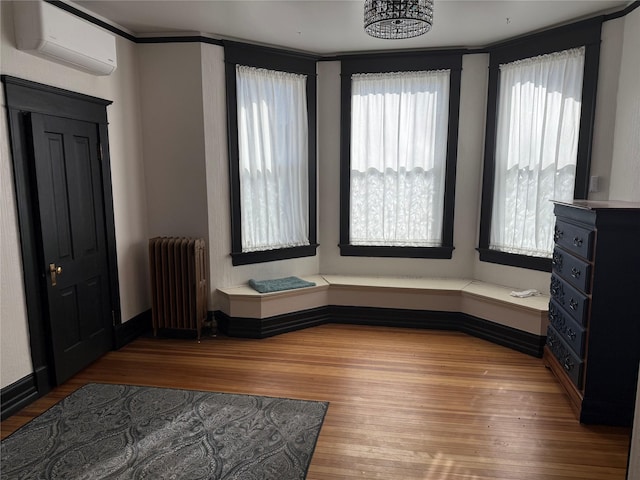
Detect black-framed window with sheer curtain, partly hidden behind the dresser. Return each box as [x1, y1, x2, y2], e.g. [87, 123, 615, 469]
[479, 18, 599, 271]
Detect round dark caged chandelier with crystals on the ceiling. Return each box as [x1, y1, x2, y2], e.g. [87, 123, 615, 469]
[364, 0, 433, 39]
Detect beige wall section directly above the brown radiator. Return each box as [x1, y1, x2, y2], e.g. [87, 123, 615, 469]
[137, 42, 209, 239]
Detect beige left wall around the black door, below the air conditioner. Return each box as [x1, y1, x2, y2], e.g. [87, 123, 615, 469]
[0, 1, 149, 387]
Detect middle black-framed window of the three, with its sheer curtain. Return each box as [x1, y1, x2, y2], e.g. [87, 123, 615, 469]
[340, 55, 461, 258]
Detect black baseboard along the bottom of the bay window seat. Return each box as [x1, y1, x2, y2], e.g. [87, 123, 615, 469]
[214, 305, 546, 358]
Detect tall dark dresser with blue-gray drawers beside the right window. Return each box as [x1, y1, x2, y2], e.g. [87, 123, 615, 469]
[543, 200, 640, 426]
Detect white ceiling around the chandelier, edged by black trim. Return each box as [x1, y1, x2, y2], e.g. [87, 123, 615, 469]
[74, 0, 631, 55]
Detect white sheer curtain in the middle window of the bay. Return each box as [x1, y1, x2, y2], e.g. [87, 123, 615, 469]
[349, 70, 450, 247]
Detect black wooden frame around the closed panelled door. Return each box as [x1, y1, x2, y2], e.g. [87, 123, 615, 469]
[0, 75, 122, 408]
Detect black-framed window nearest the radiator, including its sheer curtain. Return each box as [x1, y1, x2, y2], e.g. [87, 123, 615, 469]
[225, 44, 317, 265]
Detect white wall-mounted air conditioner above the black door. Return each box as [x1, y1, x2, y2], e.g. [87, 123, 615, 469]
[13, 0, 117, 75]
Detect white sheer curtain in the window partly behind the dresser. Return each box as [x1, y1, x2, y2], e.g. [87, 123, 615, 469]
[490, 48, 584, 257]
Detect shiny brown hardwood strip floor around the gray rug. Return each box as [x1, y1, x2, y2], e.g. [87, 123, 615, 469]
[1, 325, 630, 480]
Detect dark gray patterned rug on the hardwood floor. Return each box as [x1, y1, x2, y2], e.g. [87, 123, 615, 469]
[0, 384, 328, 480]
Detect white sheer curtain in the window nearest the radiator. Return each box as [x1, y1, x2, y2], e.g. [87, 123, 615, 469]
[236, 65, 309, 252]
